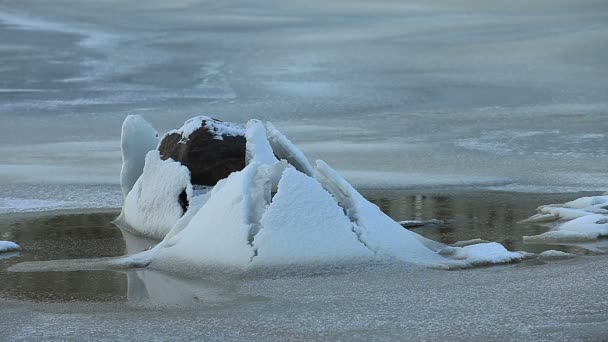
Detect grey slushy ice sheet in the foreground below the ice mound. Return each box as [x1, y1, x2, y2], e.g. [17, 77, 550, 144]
[0, 256, 608, 341]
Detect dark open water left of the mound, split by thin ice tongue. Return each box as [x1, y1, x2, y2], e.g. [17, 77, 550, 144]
[0, 213, 127, 301]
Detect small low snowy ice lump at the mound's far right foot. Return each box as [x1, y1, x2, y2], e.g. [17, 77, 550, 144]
[441, 242, 525, 266]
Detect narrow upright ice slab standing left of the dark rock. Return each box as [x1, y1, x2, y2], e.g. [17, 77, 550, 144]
[120, 115, 158, 197]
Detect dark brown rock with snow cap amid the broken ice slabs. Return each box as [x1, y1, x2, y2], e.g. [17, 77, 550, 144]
[158, 117, 246, 186]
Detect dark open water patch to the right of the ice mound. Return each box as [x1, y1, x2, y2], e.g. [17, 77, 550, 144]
[364, 191, 604, 253]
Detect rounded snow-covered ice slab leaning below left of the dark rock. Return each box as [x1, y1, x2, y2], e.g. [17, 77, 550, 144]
[117, 150, 193, 239]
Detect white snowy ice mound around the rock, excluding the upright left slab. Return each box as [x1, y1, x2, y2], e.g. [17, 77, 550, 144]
[116, 116, 524, 271]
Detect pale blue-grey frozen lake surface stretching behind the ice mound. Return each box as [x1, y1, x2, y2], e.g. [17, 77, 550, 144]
[0, 0, 608, 212]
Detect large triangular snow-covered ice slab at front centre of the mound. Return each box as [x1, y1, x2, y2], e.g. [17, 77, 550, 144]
[253, 168, 374, 265]
